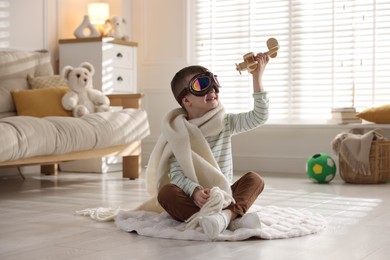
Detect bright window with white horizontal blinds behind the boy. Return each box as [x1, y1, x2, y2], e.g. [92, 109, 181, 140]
[192, 0, 390, 123]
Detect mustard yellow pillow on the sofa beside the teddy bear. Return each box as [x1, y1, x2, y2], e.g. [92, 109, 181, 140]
[12, 87, 72, 117]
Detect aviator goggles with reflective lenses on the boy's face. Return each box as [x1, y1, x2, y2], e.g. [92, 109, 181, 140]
[188, 71, 221, 97]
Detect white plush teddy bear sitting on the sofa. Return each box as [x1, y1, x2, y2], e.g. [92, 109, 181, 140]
[61, 62, 110, 117]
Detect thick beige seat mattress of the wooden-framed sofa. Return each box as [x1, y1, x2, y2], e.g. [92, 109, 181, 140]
[0, 108, 150, 162]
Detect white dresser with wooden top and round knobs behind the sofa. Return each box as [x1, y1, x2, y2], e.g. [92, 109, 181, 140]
[59, 37, 138, 94]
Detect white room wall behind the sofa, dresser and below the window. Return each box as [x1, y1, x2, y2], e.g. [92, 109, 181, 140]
[3, 0, 390, 174]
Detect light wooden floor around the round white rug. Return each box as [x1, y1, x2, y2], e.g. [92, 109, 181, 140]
[0, 170, 390, 260]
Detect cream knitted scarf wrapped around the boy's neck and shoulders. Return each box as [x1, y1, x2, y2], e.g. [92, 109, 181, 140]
[138, 105, 231, 212]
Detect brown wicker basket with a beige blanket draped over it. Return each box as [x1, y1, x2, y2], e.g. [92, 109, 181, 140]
[339, 140, 390, 184]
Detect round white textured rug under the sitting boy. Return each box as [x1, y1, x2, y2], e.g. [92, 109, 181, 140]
[115, 205, 326, 241]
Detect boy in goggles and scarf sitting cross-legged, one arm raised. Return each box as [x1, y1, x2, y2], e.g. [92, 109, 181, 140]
[146, 53, 269, 239]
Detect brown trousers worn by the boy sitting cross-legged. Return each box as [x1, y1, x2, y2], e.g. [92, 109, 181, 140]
[158, 172, 264, 221]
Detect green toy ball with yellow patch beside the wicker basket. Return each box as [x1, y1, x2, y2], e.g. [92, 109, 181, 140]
[306, 153, 336, 183]
